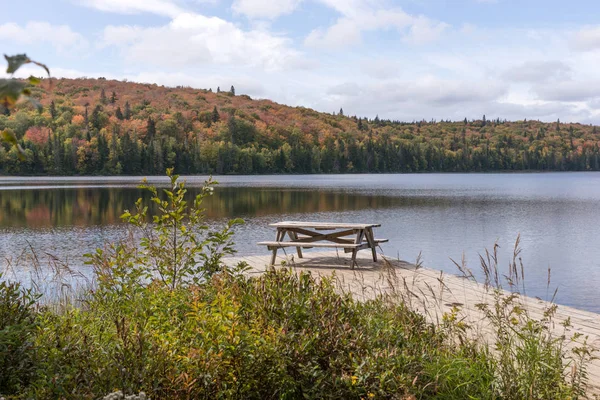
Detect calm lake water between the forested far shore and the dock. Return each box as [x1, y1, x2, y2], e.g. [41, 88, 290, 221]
[0, 173, 600, 312]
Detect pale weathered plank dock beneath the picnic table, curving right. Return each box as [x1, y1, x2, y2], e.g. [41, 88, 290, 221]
[224, 251, 600, 398]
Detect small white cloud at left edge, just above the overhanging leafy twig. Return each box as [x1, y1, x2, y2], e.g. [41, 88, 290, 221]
[0, 21, 88, 51]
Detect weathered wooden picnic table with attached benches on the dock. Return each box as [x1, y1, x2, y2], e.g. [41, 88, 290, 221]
[258, 221, 388, 268]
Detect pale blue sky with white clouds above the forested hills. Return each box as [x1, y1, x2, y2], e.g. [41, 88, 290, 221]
[0, 0, 600, 124]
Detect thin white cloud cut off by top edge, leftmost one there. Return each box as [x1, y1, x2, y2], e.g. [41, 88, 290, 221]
[83, 0, 184, 17]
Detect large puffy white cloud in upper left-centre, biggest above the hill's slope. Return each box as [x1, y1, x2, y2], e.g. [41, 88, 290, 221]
[102, 13, 305, 70]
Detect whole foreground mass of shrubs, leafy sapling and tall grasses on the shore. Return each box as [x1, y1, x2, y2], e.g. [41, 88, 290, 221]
[0, 176, 591, 400]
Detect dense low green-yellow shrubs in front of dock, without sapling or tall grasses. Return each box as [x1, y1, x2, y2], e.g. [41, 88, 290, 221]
[18, 270, 494, 399]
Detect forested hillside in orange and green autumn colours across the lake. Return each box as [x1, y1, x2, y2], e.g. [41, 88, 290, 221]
[0, 79, 600, 175]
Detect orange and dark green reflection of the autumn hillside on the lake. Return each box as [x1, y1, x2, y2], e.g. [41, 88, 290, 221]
[0, 187, 458, 229]
